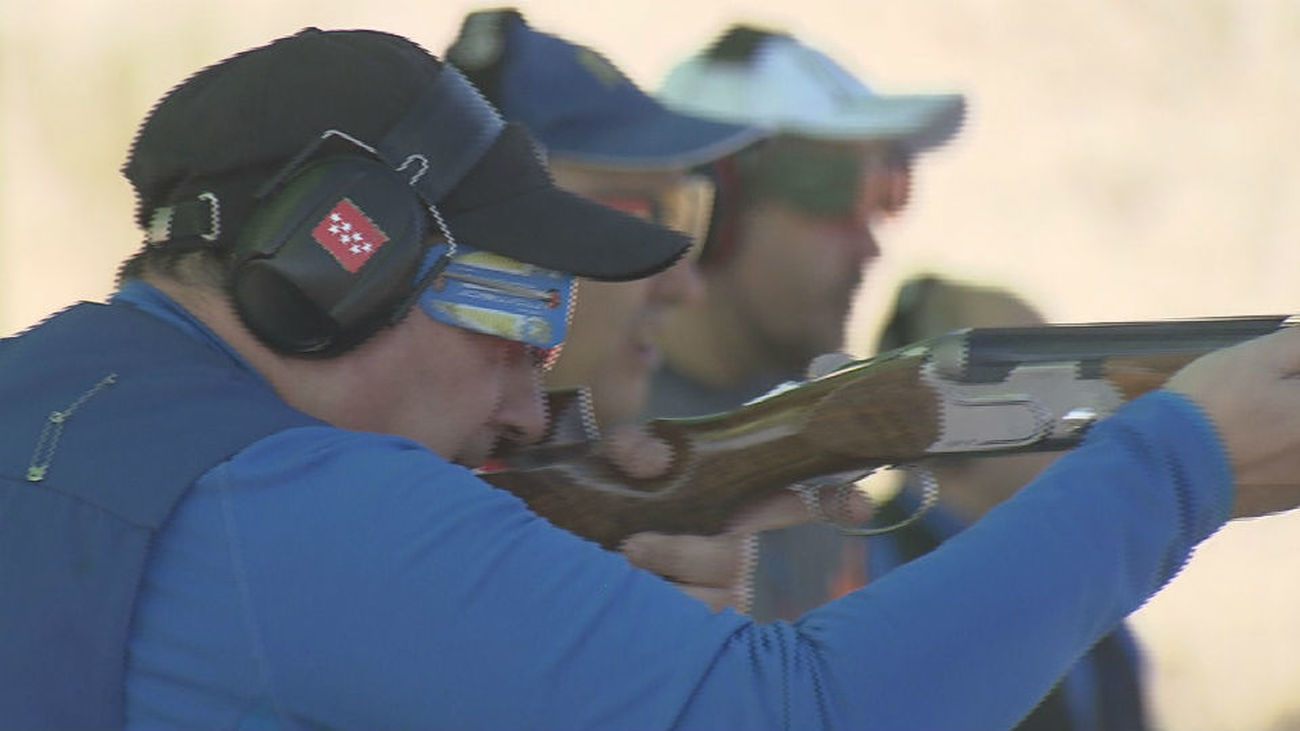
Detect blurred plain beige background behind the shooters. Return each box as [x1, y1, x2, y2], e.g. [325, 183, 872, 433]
[0, 0, 1300, 730]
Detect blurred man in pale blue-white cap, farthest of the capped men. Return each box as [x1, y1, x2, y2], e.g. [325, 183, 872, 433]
[650, 26, 965, 619]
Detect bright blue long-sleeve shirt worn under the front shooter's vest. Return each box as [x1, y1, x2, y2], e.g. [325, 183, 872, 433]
[126, 283, 1231, 728]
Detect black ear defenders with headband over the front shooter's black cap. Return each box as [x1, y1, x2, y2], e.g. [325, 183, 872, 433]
[149, 65, 504, 356]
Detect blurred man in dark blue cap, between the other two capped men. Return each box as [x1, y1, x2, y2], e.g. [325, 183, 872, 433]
[447, 10, 762, 427]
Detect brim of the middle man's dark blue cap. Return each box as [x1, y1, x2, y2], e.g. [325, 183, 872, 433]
[546, 104, 768, 168]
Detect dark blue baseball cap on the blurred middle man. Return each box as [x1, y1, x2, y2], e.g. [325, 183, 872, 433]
[446, 9, 766, 168]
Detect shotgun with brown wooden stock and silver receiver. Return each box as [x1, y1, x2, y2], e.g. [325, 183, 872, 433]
[482, 316, 1300, 549]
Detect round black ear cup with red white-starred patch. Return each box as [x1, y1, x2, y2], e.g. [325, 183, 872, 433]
[230, 155, 429, 355]
